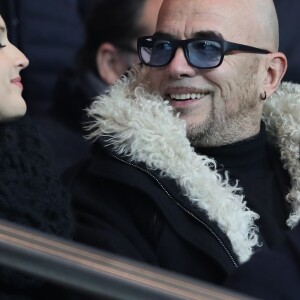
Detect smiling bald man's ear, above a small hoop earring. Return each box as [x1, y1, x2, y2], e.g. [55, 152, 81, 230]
[264, 52, 287, 97]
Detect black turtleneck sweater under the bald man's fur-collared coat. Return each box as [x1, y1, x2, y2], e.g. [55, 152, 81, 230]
[197, 123, 290, 250]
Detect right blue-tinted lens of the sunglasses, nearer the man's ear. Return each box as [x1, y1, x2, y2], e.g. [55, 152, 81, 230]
[187, 40, 222, 69]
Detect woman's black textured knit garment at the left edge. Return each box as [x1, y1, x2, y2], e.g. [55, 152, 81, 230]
[0, 117, 73, 299]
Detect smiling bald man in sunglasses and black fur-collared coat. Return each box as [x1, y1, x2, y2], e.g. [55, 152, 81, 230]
[67, 0, 300, 284]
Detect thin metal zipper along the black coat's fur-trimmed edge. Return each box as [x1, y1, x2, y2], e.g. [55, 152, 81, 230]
[112, 155, 239, 268]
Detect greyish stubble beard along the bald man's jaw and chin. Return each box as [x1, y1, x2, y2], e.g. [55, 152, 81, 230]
[180, 59, 261, 148]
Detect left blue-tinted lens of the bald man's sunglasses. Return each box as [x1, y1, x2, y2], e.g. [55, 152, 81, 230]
[139, 39, 173, 67]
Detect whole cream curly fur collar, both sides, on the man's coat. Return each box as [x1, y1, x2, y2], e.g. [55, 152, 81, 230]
[88, 67, 300, 262]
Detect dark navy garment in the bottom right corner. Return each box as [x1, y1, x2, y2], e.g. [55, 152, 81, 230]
[226, 221, 300, 300]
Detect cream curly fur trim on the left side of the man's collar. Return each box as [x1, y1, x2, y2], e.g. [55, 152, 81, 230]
[88, 67, 299, 262]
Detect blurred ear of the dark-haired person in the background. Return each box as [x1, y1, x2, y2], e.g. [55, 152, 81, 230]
[96, 43, 120, 85]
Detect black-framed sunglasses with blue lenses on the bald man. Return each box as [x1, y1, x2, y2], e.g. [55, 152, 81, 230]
[137, 36, 270, 69]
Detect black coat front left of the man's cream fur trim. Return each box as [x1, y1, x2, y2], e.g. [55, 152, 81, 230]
[65, 141, 239, 283]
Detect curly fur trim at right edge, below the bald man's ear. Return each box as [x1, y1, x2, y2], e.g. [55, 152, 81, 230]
[264, 82, 300, 228]
